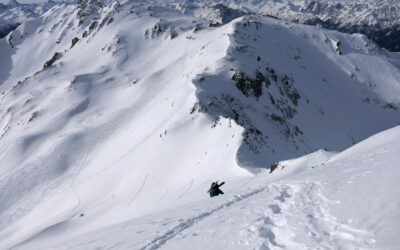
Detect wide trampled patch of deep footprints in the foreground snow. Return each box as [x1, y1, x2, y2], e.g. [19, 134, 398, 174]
[257, 181, 371, 250]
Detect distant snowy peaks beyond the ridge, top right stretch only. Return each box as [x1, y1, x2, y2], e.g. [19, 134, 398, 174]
[150, 0, 400, 51]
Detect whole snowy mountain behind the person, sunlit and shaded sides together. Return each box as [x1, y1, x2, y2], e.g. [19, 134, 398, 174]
[0, 0, 400, 248]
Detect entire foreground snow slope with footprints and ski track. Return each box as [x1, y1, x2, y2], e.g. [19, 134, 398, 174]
[16, 126, 400, 250]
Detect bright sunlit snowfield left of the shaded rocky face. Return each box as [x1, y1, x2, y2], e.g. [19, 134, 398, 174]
[0, 1, 253, 248]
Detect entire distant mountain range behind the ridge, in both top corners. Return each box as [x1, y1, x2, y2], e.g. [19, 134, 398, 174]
[0, 0, 400, 51]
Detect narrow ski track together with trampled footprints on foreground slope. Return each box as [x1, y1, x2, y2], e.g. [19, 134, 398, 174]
[135, 181, 374, 250]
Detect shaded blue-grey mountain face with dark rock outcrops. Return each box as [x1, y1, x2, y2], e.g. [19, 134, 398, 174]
[194, 17, 400, 166]
